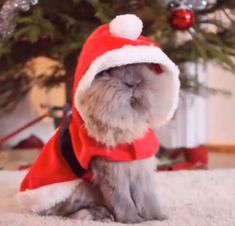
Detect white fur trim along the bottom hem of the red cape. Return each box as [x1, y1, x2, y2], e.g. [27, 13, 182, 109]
[17, 179, 82, 213]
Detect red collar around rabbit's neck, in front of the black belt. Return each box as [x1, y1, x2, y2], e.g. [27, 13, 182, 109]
[70, 114, 159, 169]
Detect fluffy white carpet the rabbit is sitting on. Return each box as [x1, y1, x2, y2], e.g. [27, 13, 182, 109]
[0, 169, 235, 226]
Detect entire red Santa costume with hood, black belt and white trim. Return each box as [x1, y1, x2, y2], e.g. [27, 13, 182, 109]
[18, 14, 179, 212]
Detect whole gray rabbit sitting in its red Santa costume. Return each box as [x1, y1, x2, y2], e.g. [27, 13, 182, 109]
[19, 15, 179, 223]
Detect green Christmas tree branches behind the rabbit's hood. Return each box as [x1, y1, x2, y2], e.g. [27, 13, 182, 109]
[0, 0, 235, 109]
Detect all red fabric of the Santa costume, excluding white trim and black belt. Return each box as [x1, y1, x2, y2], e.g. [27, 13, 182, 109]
[20, 21, 161, 191]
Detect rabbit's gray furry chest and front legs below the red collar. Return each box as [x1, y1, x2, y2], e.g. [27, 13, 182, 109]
[92, 158, 165, 223]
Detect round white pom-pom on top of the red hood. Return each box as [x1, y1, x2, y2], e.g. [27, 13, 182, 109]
[109, 14, 143, 40]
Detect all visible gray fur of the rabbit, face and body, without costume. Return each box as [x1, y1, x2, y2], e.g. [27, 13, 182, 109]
[42, 64, 165, 223]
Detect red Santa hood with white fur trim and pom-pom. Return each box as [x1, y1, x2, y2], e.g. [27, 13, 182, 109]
[74, 14, 180, 126]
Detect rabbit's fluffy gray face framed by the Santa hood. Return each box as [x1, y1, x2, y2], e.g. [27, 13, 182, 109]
[77, 64, 161, 146]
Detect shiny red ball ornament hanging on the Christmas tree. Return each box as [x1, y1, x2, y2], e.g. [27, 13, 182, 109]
[170, 8, 195, 31]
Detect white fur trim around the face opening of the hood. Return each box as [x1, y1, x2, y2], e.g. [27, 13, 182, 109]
[74, 45, 180, 127]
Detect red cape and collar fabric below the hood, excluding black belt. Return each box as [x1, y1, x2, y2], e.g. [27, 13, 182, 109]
[20, 124, 159, 191]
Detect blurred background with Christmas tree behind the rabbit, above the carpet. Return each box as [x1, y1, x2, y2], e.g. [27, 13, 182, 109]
[0, 0, 235, 170]
